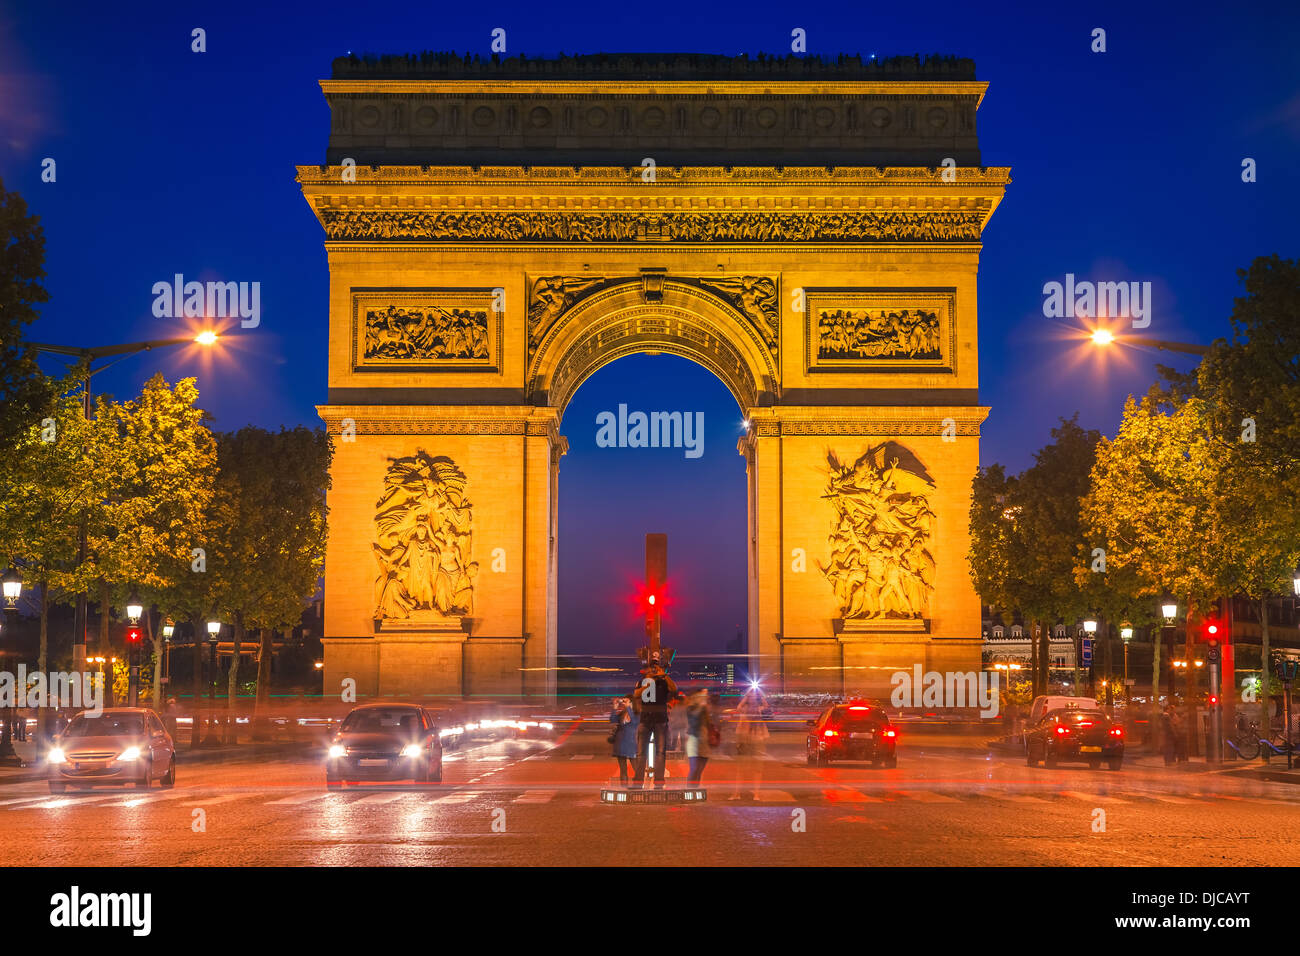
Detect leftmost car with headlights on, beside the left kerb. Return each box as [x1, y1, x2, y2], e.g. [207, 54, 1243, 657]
[46, 708, 176, 793]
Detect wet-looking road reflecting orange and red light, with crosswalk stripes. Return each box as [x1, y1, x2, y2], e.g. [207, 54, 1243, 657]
[0, 728, 1300, 866]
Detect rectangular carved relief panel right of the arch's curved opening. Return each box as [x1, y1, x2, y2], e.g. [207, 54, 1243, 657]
[803, 289, 957, 373]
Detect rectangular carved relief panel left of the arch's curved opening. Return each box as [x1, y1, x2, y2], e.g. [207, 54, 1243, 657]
[352, 289, 504, 373]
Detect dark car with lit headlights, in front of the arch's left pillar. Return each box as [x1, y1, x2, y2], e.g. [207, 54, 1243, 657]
[325, 704, 442, 787]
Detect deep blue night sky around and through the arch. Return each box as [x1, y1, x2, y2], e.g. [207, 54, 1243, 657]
[0, 0, 1300, 652]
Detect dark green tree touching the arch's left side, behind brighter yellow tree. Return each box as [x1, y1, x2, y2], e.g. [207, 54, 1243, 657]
[208, 427, 332, 738]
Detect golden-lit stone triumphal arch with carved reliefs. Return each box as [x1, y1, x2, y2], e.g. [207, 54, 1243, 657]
[298, 56, 1009, 695]
